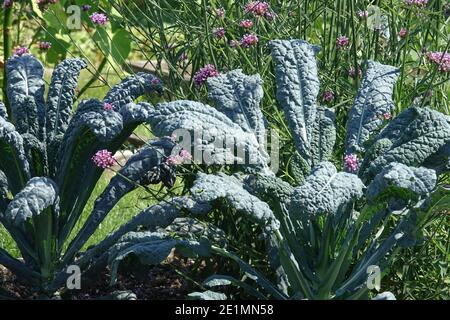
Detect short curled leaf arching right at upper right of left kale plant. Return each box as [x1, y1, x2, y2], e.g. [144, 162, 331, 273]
[103, 72, 163, 111]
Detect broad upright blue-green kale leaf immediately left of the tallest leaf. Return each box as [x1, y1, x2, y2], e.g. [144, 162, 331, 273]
[207, 69, 266, 145]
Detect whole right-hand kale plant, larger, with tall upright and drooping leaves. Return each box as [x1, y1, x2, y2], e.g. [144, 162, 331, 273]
[135, 40, 450, 299]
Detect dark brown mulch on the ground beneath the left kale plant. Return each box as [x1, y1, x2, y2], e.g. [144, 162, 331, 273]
[0, 259, 194, 300]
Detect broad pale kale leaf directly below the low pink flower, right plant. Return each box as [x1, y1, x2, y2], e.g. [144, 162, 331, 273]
[289, 162, 364, 219]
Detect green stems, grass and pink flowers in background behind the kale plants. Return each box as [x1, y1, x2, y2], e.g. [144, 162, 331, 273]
[0, 0, 450, 299]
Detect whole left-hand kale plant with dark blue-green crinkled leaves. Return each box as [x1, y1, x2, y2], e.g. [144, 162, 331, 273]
[0, 54, 213, 295]
